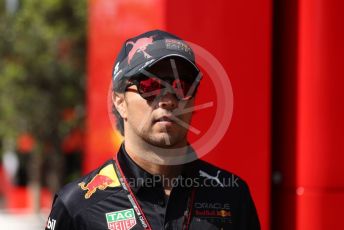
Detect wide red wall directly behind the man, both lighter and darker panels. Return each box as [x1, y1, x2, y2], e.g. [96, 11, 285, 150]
[85, 0, 272, 229]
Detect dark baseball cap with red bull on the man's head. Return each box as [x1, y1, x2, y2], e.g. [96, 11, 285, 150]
[112, 30, 200, 83]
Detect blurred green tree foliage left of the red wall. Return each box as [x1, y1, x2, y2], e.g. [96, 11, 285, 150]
[0, 0, 87, 141]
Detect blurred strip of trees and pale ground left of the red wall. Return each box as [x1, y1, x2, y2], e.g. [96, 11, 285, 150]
[0, 0, 87, 229]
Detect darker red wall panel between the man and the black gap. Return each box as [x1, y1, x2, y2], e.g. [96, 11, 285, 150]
[166, 0, 272, 229]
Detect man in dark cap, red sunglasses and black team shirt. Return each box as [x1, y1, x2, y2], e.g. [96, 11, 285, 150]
[46, 30, 260, 230]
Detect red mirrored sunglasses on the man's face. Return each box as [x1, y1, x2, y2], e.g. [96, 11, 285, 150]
[126, 75, 200, 101]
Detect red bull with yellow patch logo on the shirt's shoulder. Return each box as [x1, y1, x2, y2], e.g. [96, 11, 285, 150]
[78, 164, 120, 199]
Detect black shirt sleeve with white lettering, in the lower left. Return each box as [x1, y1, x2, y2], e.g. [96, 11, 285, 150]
[45, 195, 75, 230]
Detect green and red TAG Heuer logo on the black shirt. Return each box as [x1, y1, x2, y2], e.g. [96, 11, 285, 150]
[105, 208, 136, 230]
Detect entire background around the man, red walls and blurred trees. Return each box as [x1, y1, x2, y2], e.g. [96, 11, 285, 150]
[0, 0, 344, 230]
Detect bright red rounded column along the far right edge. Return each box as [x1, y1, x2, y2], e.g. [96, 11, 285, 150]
[297, 0, 344, 230]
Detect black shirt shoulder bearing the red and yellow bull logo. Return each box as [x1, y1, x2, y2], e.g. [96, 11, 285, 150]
[55, 160, 121, 215]
